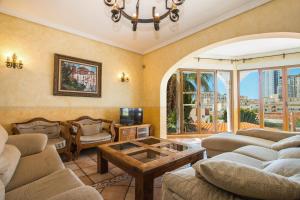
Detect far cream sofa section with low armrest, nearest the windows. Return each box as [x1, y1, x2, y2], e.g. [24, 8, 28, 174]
[202, 129, 300, 157]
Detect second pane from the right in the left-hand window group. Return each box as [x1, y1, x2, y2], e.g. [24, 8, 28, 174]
[200, 72, 215, 133]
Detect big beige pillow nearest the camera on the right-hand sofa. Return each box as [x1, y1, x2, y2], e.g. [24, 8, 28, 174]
[197, 160, 300, 200]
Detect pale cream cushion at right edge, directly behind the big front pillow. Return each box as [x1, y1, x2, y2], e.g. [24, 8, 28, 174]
[263, 159, 300, 177]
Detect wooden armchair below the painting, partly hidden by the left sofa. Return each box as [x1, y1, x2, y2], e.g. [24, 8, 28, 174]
[12, 118, 72, 160]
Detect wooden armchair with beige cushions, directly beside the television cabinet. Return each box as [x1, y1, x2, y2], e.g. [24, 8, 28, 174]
[68, 116, 116, 157]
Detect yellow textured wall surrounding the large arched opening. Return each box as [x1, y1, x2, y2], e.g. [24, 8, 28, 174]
[143, 0, 300, 136]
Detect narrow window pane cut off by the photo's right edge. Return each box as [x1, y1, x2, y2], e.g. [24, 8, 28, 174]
[287, 68, 300, 131]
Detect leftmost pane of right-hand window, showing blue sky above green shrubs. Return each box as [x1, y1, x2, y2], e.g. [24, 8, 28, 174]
[240, 70, 259, 129]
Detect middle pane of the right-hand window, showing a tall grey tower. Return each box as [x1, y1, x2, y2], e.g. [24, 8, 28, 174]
[262, 70, 284, 129]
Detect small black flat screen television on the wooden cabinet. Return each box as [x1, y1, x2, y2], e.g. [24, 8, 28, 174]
[120, 108, 143, 125]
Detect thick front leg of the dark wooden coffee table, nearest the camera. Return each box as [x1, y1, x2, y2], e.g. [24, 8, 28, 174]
[135, 175, 154, 200]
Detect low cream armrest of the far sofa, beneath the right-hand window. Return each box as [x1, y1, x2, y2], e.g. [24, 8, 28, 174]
[236, 128, 300, 142]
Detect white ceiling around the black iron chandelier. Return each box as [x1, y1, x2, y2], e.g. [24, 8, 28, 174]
[0, 0, 270, 54]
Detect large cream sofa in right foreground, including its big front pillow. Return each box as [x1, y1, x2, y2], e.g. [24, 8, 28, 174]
[162, 141, 300, 200]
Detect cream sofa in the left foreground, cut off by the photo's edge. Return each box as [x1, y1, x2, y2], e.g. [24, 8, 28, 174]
[0, 125, 102, 200]
